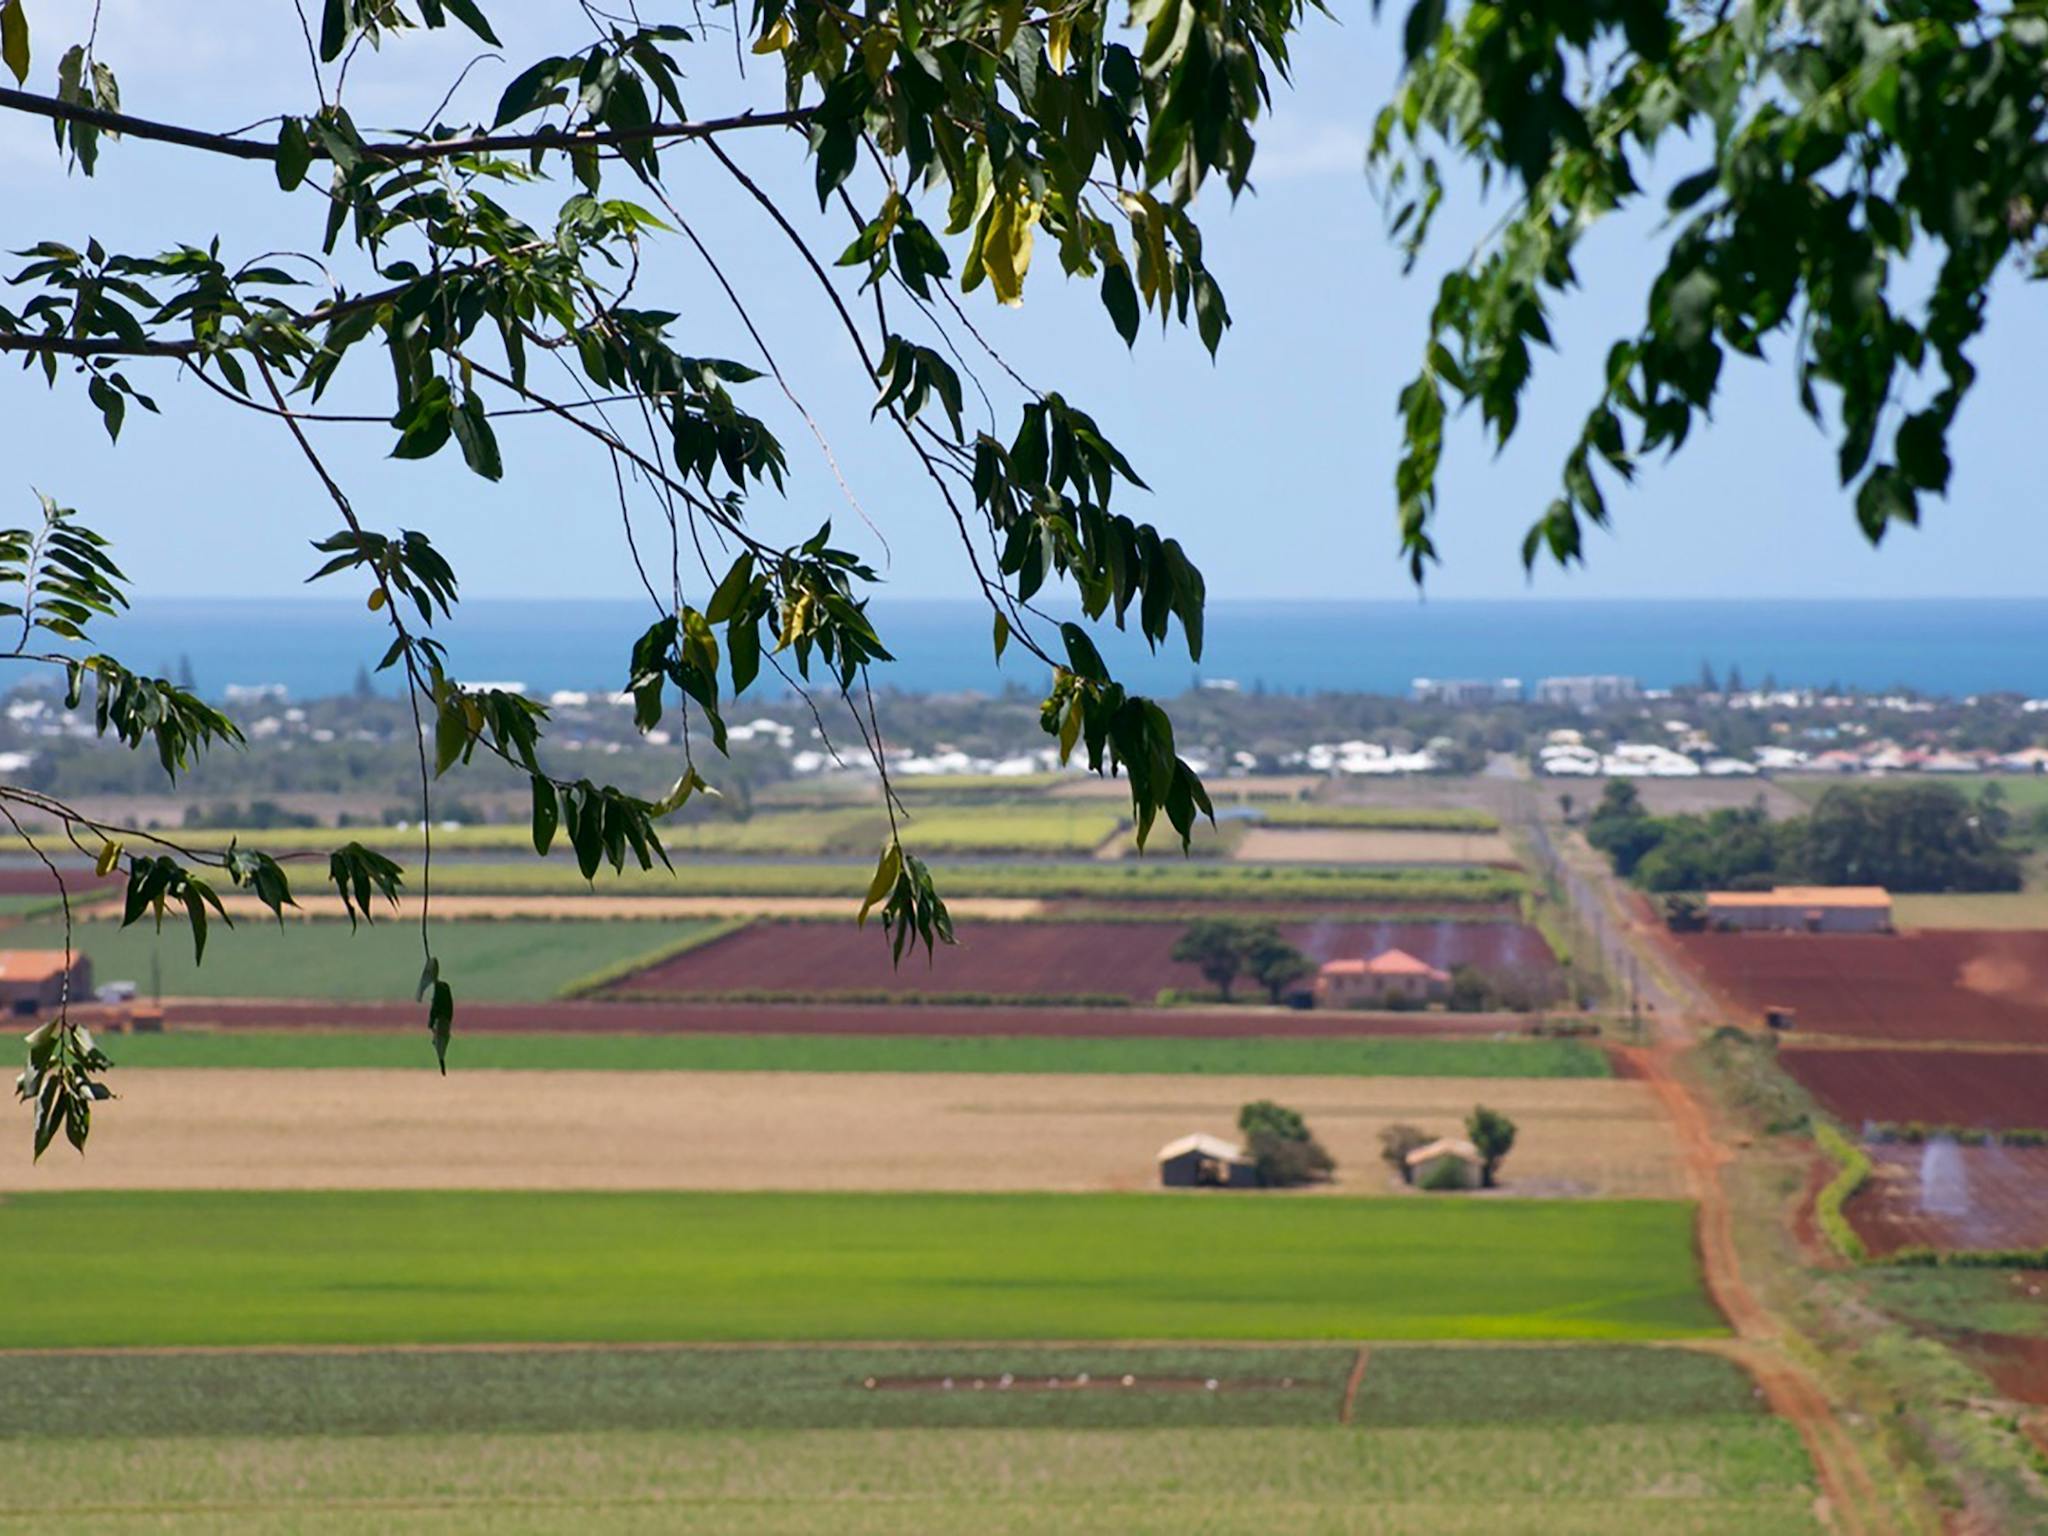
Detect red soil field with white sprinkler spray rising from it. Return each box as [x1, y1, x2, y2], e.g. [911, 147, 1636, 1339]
[1843, 1143, 2048, 1257]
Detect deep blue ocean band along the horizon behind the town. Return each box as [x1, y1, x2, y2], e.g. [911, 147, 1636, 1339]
[79, 598, 2048, 698]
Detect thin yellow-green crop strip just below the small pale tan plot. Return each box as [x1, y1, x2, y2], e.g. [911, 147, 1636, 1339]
[434, 860, 1528, 907]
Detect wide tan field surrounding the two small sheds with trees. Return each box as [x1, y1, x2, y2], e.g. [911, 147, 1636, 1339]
[0, 1069, 1683, 1198]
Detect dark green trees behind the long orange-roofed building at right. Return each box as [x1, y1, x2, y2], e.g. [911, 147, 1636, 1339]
[1585, 780, 2019, 891]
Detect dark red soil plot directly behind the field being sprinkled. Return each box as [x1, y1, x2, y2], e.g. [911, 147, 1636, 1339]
[1778, 1047, 2048, 1130]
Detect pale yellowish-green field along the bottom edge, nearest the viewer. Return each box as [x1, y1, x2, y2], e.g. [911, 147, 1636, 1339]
[0, 1417, 1821, 1536]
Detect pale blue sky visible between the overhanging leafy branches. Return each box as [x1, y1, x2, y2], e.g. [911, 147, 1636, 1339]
[0, 0, 2048, 598]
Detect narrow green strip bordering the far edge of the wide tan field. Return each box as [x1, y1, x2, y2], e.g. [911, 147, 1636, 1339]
[104, 1030, 1612, 1077]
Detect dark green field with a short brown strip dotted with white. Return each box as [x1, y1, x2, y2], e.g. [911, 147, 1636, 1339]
[0, 1343, 1763, 1440]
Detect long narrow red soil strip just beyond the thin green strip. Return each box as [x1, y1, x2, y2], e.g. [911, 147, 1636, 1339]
[164, 997, 1530, 1038]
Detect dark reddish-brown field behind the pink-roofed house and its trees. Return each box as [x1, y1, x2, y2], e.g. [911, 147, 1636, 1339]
[606, 922, 1556, 1001]
